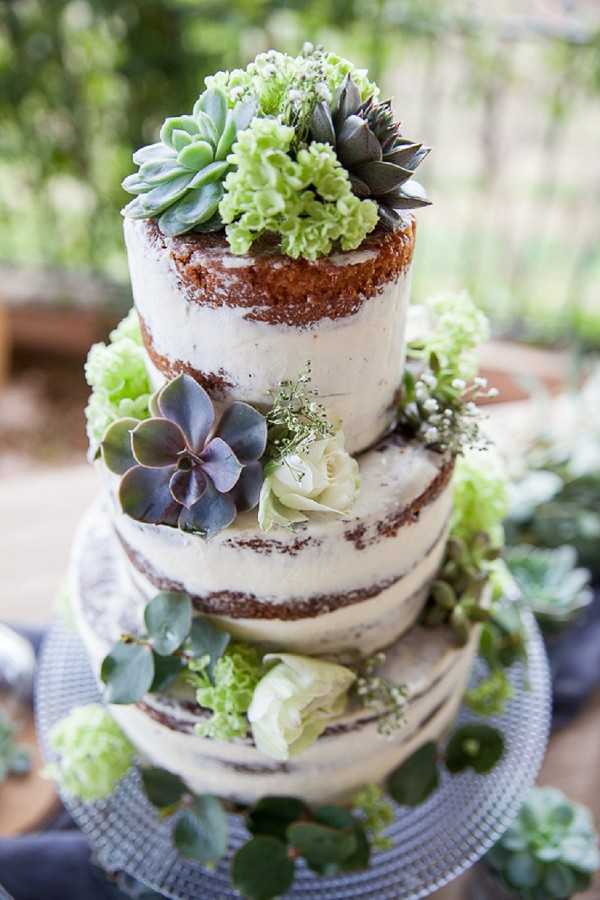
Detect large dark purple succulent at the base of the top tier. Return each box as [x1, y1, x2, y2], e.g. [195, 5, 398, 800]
[102, 375, 267, 536]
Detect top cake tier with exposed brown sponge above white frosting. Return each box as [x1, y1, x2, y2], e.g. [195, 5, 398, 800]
[125, 216, 415, 453]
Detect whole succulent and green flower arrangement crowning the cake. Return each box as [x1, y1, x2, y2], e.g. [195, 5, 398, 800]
[123, 45, 429, 260]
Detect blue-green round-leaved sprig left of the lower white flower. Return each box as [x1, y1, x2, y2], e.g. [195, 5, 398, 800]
[100, 591, 230, 704]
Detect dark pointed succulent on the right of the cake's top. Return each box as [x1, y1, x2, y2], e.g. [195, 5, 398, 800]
[310, 74, 429, 229]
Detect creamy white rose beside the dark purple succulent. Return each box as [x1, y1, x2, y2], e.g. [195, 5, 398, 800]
[258, 431, 360, 531]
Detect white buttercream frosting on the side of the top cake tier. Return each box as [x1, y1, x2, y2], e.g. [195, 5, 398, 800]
[125, 219, 410, 454]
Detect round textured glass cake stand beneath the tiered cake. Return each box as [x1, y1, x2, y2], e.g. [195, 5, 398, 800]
[37, 618, 550, 900]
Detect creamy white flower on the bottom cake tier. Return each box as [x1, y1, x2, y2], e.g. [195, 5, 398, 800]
[248, 653, 356, 760]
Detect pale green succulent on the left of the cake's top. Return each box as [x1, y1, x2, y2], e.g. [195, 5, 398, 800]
[123, 88, 256, 236]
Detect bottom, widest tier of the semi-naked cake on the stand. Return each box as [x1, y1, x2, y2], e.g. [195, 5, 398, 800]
[71, 507, 478, 803]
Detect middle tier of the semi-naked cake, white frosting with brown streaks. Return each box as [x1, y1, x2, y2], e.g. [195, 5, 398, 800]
[105, 435, 453, 655]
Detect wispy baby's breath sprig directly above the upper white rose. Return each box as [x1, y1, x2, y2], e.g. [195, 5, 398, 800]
[266, 362, 334, 465]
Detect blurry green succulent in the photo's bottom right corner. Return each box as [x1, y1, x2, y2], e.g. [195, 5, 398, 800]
[485, 787, 600, 900]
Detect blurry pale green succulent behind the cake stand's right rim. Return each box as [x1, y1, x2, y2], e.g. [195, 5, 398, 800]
[506, 544, 593, 631]
